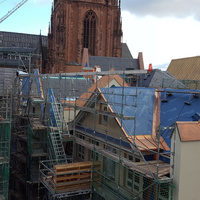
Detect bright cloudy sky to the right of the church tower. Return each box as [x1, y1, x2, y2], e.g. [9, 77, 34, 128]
[119, 0, 200, 69]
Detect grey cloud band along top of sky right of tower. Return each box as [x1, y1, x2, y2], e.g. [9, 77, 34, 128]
[122, 0, 200, 20]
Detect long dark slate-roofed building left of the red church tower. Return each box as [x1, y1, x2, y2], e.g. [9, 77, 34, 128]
[0, 31, 47, 72]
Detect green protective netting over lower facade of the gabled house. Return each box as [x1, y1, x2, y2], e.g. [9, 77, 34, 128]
[92, 152, 173, 200]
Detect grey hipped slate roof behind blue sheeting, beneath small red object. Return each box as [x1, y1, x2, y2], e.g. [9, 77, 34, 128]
[139, 69, 186, 88]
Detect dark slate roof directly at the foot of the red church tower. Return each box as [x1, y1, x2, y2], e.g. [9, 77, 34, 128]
[89, 56, 140, 71]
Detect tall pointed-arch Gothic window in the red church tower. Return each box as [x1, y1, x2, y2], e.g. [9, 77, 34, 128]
[83, 10, 97, 55]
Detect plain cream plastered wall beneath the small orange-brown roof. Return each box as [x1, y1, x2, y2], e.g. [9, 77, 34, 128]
[172, 129, 200, 200]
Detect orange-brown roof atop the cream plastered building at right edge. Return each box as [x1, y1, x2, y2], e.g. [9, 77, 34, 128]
[176, 122, 200, 142]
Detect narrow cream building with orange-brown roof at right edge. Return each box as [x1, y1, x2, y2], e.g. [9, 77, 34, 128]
[171, 121, 200, 200]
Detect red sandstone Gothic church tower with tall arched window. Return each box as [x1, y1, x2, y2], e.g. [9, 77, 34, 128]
[45, 0, 122, 73]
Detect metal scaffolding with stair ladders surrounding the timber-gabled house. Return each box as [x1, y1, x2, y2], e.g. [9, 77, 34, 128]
[7, 70, 176, 200]
